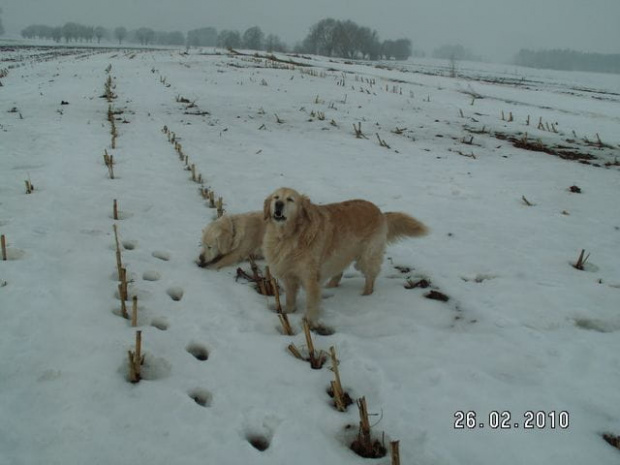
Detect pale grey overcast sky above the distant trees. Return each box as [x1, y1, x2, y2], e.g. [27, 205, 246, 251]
[0, 0, 620, 61]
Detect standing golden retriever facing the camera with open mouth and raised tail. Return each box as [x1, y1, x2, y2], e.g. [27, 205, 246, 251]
[262, 187, 428, 327]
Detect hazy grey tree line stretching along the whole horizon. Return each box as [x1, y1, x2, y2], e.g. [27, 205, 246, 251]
[19, 17, 620, 73]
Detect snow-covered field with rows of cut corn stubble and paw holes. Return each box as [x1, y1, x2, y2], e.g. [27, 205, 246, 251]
[0, 48, 620, 465]
